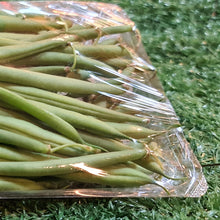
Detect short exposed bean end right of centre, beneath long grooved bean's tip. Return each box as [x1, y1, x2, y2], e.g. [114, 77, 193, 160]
[108, 122, 164, 139]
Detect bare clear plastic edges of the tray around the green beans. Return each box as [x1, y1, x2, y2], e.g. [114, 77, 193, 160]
[0, 1, 207, 199]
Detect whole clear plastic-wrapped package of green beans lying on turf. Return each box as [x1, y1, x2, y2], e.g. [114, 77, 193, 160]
[0, 1, 207, 199]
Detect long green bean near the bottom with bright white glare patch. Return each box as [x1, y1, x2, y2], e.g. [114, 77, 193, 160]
[0, 150, 146, 177]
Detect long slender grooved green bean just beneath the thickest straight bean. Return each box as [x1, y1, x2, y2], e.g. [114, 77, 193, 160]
[3, 84, 144, 123]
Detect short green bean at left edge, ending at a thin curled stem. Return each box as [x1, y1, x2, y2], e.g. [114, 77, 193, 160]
[0, 129, 50, 153]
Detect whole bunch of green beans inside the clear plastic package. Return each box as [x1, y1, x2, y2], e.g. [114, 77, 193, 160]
[0, 11, 180, 193]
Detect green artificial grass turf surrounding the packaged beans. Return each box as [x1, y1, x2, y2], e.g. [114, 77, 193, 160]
[0, 0, 220, 220]
